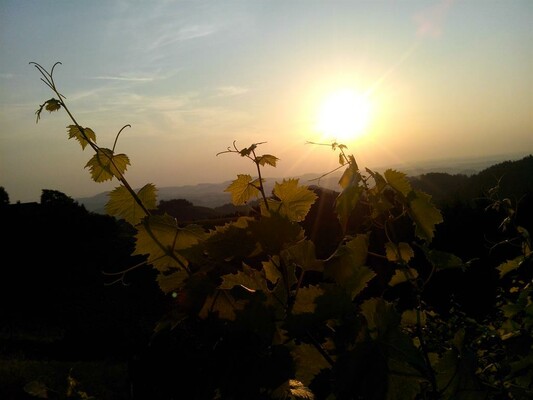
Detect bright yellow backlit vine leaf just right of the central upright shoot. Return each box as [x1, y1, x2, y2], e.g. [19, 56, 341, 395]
[263, 179, 318, 222]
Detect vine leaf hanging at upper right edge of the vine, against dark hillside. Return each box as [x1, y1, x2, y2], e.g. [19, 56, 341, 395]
[409, 191, 443, 242]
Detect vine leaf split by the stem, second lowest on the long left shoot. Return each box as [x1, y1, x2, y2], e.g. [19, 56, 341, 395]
[105, 183, 157, 225]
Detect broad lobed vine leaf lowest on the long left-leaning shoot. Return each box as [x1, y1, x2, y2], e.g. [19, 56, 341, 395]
[132, 214, 206, 272]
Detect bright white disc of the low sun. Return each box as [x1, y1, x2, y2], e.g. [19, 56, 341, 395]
[316, 89, 372, 144]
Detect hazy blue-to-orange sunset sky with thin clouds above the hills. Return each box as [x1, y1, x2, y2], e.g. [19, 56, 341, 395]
[0, 0, 533, 203]
